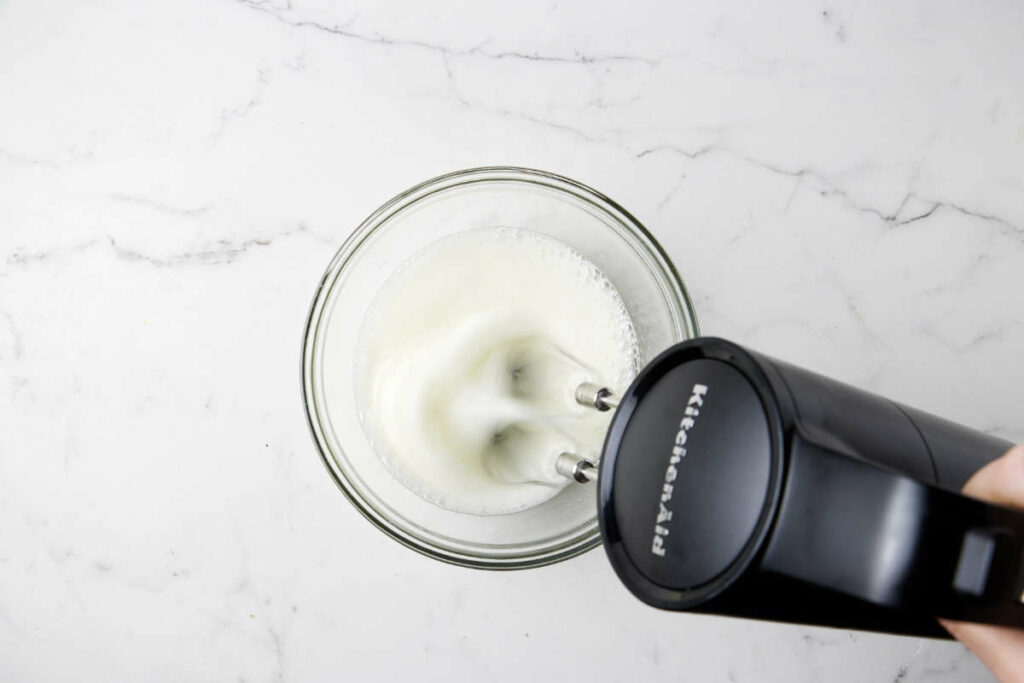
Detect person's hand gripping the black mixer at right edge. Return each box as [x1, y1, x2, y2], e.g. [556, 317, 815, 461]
[939, 444, 1024, 683]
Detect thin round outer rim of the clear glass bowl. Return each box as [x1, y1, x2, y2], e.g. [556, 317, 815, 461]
[301, 166, 699, 569]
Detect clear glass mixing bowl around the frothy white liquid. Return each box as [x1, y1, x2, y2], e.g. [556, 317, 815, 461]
[302, 167, 697, 569]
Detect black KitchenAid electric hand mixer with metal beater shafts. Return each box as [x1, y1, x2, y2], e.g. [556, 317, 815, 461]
[556, 338, 1024, 637]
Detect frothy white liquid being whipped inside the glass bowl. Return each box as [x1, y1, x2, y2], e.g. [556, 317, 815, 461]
[355, 228, 638, 514]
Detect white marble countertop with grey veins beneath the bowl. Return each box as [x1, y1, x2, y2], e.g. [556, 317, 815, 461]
[0, 0, 1024, 682]
